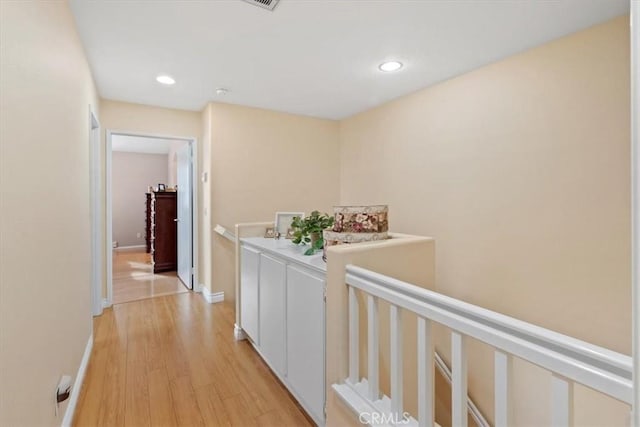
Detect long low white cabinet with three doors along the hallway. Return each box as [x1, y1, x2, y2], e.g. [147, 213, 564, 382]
[240, 237, 326, 425]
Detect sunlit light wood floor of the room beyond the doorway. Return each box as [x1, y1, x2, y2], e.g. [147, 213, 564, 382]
[113, 249, 188, 304]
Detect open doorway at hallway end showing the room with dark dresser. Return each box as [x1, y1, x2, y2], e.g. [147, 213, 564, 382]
[105, 131, 198, 306]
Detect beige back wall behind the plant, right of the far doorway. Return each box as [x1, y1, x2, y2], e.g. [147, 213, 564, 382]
[204, 104, 340, 300]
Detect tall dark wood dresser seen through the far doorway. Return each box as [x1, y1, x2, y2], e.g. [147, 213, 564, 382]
[151, 191, 178, 273]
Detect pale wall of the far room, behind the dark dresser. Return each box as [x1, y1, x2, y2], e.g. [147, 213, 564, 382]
[111, 151, 169, 246]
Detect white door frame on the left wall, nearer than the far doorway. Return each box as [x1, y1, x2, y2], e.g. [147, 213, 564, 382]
[89, 105, 103, 316]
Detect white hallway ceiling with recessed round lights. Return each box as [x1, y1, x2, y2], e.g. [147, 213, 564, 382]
[71, 0, 629, 119]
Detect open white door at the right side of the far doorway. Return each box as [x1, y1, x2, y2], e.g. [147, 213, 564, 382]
[176, 144, 193, 289]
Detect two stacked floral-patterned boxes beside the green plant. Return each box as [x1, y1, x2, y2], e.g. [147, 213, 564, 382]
[322, 205, 389, 261]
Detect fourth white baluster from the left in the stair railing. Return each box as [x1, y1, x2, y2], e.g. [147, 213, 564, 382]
[418, 317, 435, 427]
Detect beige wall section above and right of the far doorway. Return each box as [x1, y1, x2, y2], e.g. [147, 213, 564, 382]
[100, 99, 204, 295]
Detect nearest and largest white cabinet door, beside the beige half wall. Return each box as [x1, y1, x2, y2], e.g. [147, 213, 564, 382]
[287, 266, 325, 419]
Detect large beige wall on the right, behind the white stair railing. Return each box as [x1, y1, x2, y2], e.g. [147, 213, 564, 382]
[340, 17, 631, 425]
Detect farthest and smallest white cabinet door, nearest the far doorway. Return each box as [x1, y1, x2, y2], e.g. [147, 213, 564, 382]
[240, 246, 260, 345]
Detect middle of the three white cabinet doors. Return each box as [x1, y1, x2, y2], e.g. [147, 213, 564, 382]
[259, 254, 286, 375]
